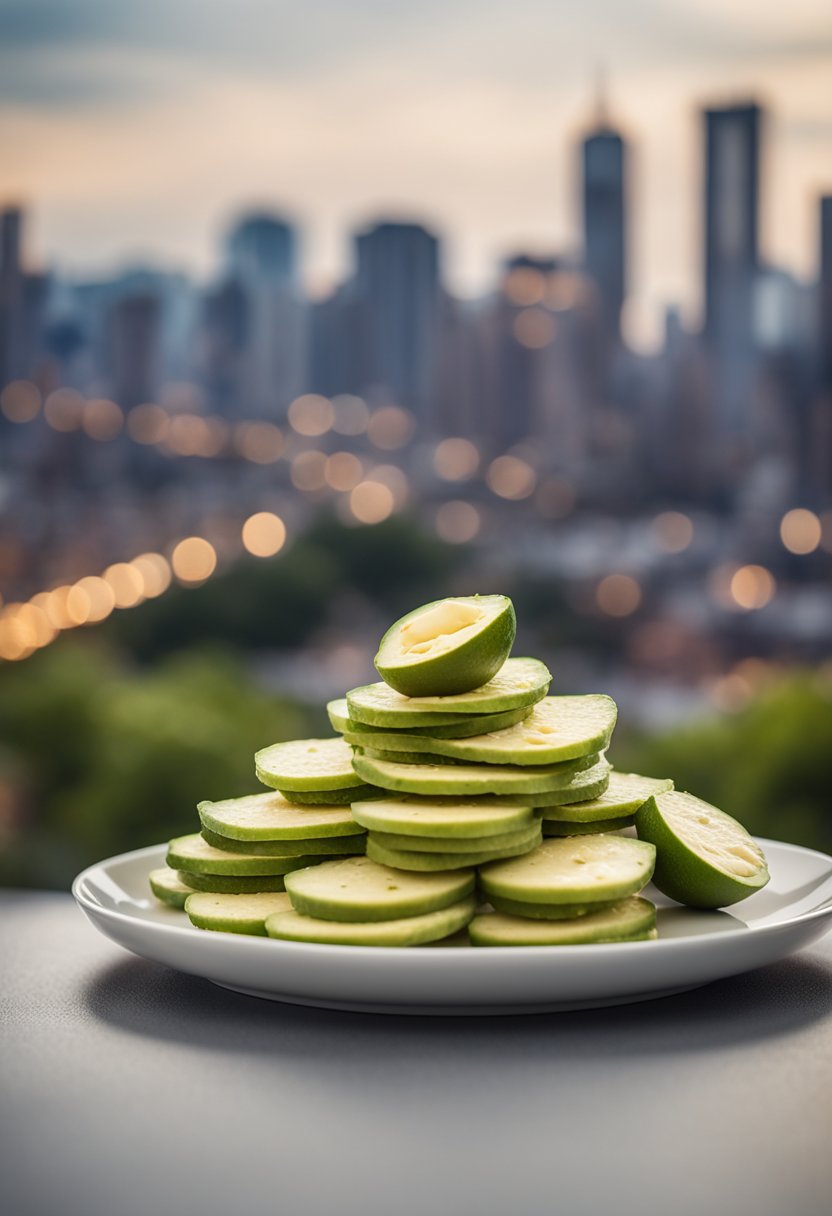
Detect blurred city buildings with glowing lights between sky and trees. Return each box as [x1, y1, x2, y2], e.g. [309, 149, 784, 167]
[0, 92, 832, 710]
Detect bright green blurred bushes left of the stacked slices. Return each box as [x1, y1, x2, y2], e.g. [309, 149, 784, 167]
[0, 638, 311, 886]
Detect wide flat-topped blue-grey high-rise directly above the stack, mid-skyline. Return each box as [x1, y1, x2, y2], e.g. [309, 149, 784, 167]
[354, 221, 442, 423]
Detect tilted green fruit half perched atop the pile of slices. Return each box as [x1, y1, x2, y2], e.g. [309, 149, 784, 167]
[375, 596, 517, 697]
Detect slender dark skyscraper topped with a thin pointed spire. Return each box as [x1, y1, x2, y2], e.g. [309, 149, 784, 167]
[581, 73, 626, 345]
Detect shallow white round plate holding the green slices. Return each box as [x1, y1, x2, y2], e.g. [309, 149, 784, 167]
[72, 840, 832, 1014]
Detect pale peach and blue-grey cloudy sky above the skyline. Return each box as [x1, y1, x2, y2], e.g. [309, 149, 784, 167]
[0, 0, 832, 340]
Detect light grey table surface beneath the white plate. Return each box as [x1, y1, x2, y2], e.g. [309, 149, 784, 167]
[0, 893, 832, 1216]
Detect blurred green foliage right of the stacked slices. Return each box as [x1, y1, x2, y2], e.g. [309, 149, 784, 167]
[611, 672, 832, 852]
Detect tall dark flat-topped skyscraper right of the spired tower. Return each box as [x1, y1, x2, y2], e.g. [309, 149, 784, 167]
[704, 102, 761, 434]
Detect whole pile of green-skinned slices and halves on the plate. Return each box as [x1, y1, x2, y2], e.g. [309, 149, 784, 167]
[151, 596, 769, 946]
